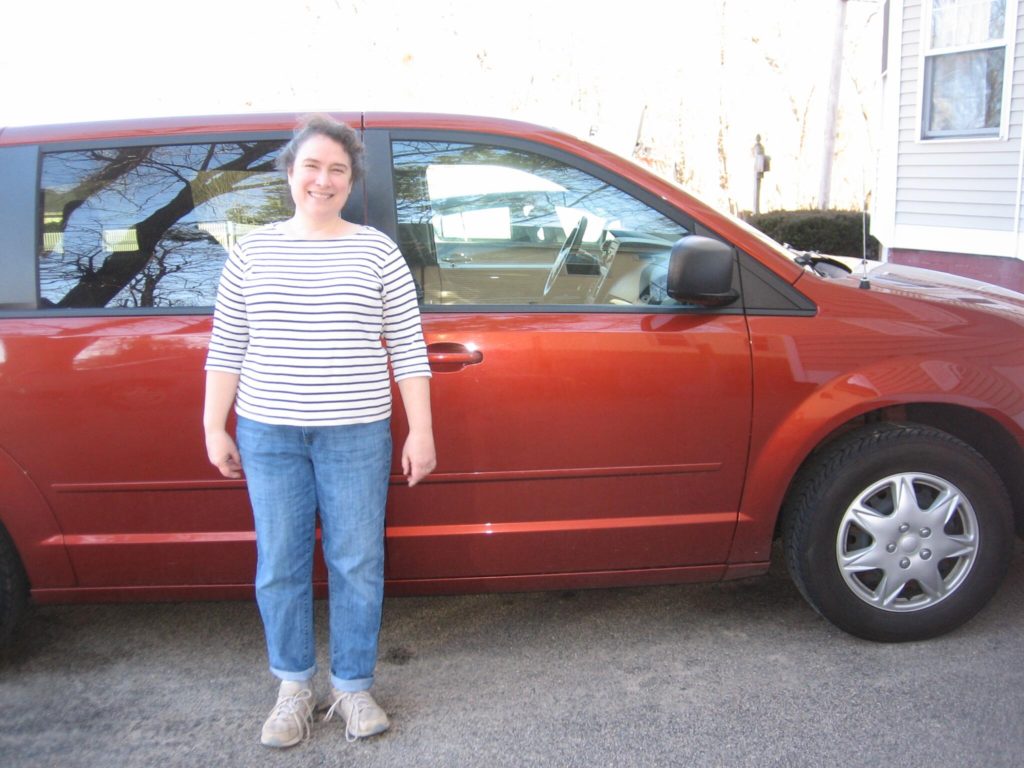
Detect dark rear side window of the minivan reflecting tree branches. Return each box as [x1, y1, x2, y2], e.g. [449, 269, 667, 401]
[38, 141, 290, 308]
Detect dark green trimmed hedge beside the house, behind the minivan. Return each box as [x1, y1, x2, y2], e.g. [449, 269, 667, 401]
[745, 211, 879, 259]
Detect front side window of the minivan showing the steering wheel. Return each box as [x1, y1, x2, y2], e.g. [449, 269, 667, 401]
[392, 140, 689, 306]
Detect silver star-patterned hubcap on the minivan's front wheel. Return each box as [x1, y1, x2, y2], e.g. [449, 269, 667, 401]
[836, 472, 978, 611]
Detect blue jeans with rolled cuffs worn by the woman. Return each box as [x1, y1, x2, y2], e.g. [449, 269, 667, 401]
[237, 417, 391, 691]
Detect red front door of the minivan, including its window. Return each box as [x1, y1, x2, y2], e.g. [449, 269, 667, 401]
[368, 131, 751, 589]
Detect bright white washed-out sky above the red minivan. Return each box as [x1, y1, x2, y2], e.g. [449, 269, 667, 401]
[0, 0, 881, 207]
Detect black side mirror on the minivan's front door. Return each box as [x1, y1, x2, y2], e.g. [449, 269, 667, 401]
[667, 234, 739, 307]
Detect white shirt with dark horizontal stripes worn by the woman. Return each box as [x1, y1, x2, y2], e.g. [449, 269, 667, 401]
[206, 224, 430, 426]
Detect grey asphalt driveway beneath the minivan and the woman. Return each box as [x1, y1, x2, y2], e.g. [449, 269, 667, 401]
[0, 542, 1024, 768]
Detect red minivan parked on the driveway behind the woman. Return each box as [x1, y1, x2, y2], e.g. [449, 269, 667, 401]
[0, 114, 1024, 641]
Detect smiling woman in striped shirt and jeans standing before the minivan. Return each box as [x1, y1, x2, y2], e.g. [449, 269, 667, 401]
[204, 116, 435, 746]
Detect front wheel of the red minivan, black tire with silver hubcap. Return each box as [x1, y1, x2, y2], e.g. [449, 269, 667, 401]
[782, 424, 1014, 642]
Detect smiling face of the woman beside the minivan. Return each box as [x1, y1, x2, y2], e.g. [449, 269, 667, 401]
[288, 134, 352, 220]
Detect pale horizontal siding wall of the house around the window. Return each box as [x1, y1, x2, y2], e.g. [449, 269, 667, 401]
[877, 0, 1024, 290]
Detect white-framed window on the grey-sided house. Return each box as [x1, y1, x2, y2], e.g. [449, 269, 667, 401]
[922, 0, 1016, 138]
